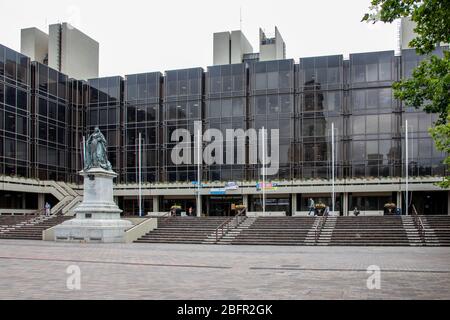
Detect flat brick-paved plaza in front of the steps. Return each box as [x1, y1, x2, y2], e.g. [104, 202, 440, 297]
[0, 240, 450, 300]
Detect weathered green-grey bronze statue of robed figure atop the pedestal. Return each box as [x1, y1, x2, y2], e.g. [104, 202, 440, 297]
[84, 127, 112, 171]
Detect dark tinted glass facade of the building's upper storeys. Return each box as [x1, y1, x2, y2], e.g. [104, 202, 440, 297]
[0, 42, 446, 188]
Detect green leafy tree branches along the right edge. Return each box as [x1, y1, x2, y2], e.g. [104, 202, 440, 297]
[362, 0, 450, 188]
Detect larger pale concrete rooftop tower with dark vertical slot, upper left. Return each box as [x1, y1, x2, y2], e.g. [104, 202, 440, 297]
[49, 23, 99, 80]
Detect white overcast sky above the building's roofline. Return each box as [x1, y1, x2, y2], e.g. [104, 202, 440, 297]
[0, 0, 397, 76]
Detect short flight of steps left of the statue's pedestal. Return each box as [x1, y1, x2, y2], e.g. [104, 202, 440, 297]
[0, 215, 73, 240]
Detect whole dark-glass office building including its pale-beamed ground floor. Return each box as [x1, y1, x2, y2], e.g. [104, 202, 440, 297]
[0, 40, 450, 215]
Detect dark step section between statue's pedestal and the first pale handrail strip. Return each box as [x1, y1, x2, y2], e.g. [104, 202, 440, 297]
[135, 217, 228, 244]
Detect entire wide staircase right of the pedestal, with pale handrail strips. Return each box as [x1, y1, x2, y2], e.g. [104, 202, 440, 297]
[136, 216, 450, 247]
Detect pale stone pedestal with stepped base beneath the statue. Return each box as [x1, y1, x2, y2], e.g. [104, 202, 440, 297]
[55, 168, 132, 243]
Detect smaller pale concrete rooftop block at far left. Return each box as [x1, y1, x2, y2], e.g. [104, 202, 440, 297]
[20, 28, 48, 63]
